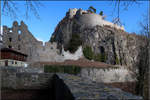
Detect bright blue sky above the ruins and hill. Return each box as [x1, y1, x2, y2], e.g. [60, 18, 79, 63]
[1, 1, 148, 42]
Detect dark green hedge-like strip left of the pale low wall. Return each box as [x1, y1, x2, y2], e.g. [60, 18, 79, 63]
[44, 65, 81, 75]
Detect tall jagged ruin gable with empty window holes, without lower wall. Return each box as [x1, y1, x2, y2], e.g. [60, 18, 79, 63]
[3, 21, 40, 61]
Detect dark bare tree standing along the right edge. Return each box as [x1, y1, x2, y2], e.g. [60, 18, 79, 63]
[136, 9, 150, 99]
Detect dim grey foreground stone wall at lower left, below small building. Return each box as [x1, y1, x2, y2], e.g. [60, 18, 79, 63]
[0, 67, 49, 89]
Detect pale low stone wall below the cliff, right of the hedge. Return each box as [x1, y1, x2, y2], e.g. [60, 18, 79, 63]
[80, 67, 136, 83]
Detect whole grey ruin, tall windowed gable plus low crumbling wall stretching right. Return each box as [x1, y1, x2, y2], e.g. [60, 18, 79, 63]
[2, 21, 83, 63]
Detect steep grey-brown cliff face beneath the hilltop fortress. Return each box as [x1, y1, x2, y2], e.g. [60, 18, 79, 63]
[50, 9, 145, 66]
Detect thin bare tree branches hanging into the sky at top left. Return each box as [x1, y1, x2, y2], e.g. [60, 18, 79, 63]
[1, 0, 43, 19]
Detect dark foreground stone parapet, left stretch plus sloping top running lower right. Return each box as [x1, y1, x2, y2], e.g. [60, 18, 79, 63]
[0, 67, 142, 100]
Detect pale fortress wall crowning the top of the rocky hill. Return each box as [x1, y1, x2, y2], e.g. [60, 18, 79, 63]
[67, 8, 124, 30]
